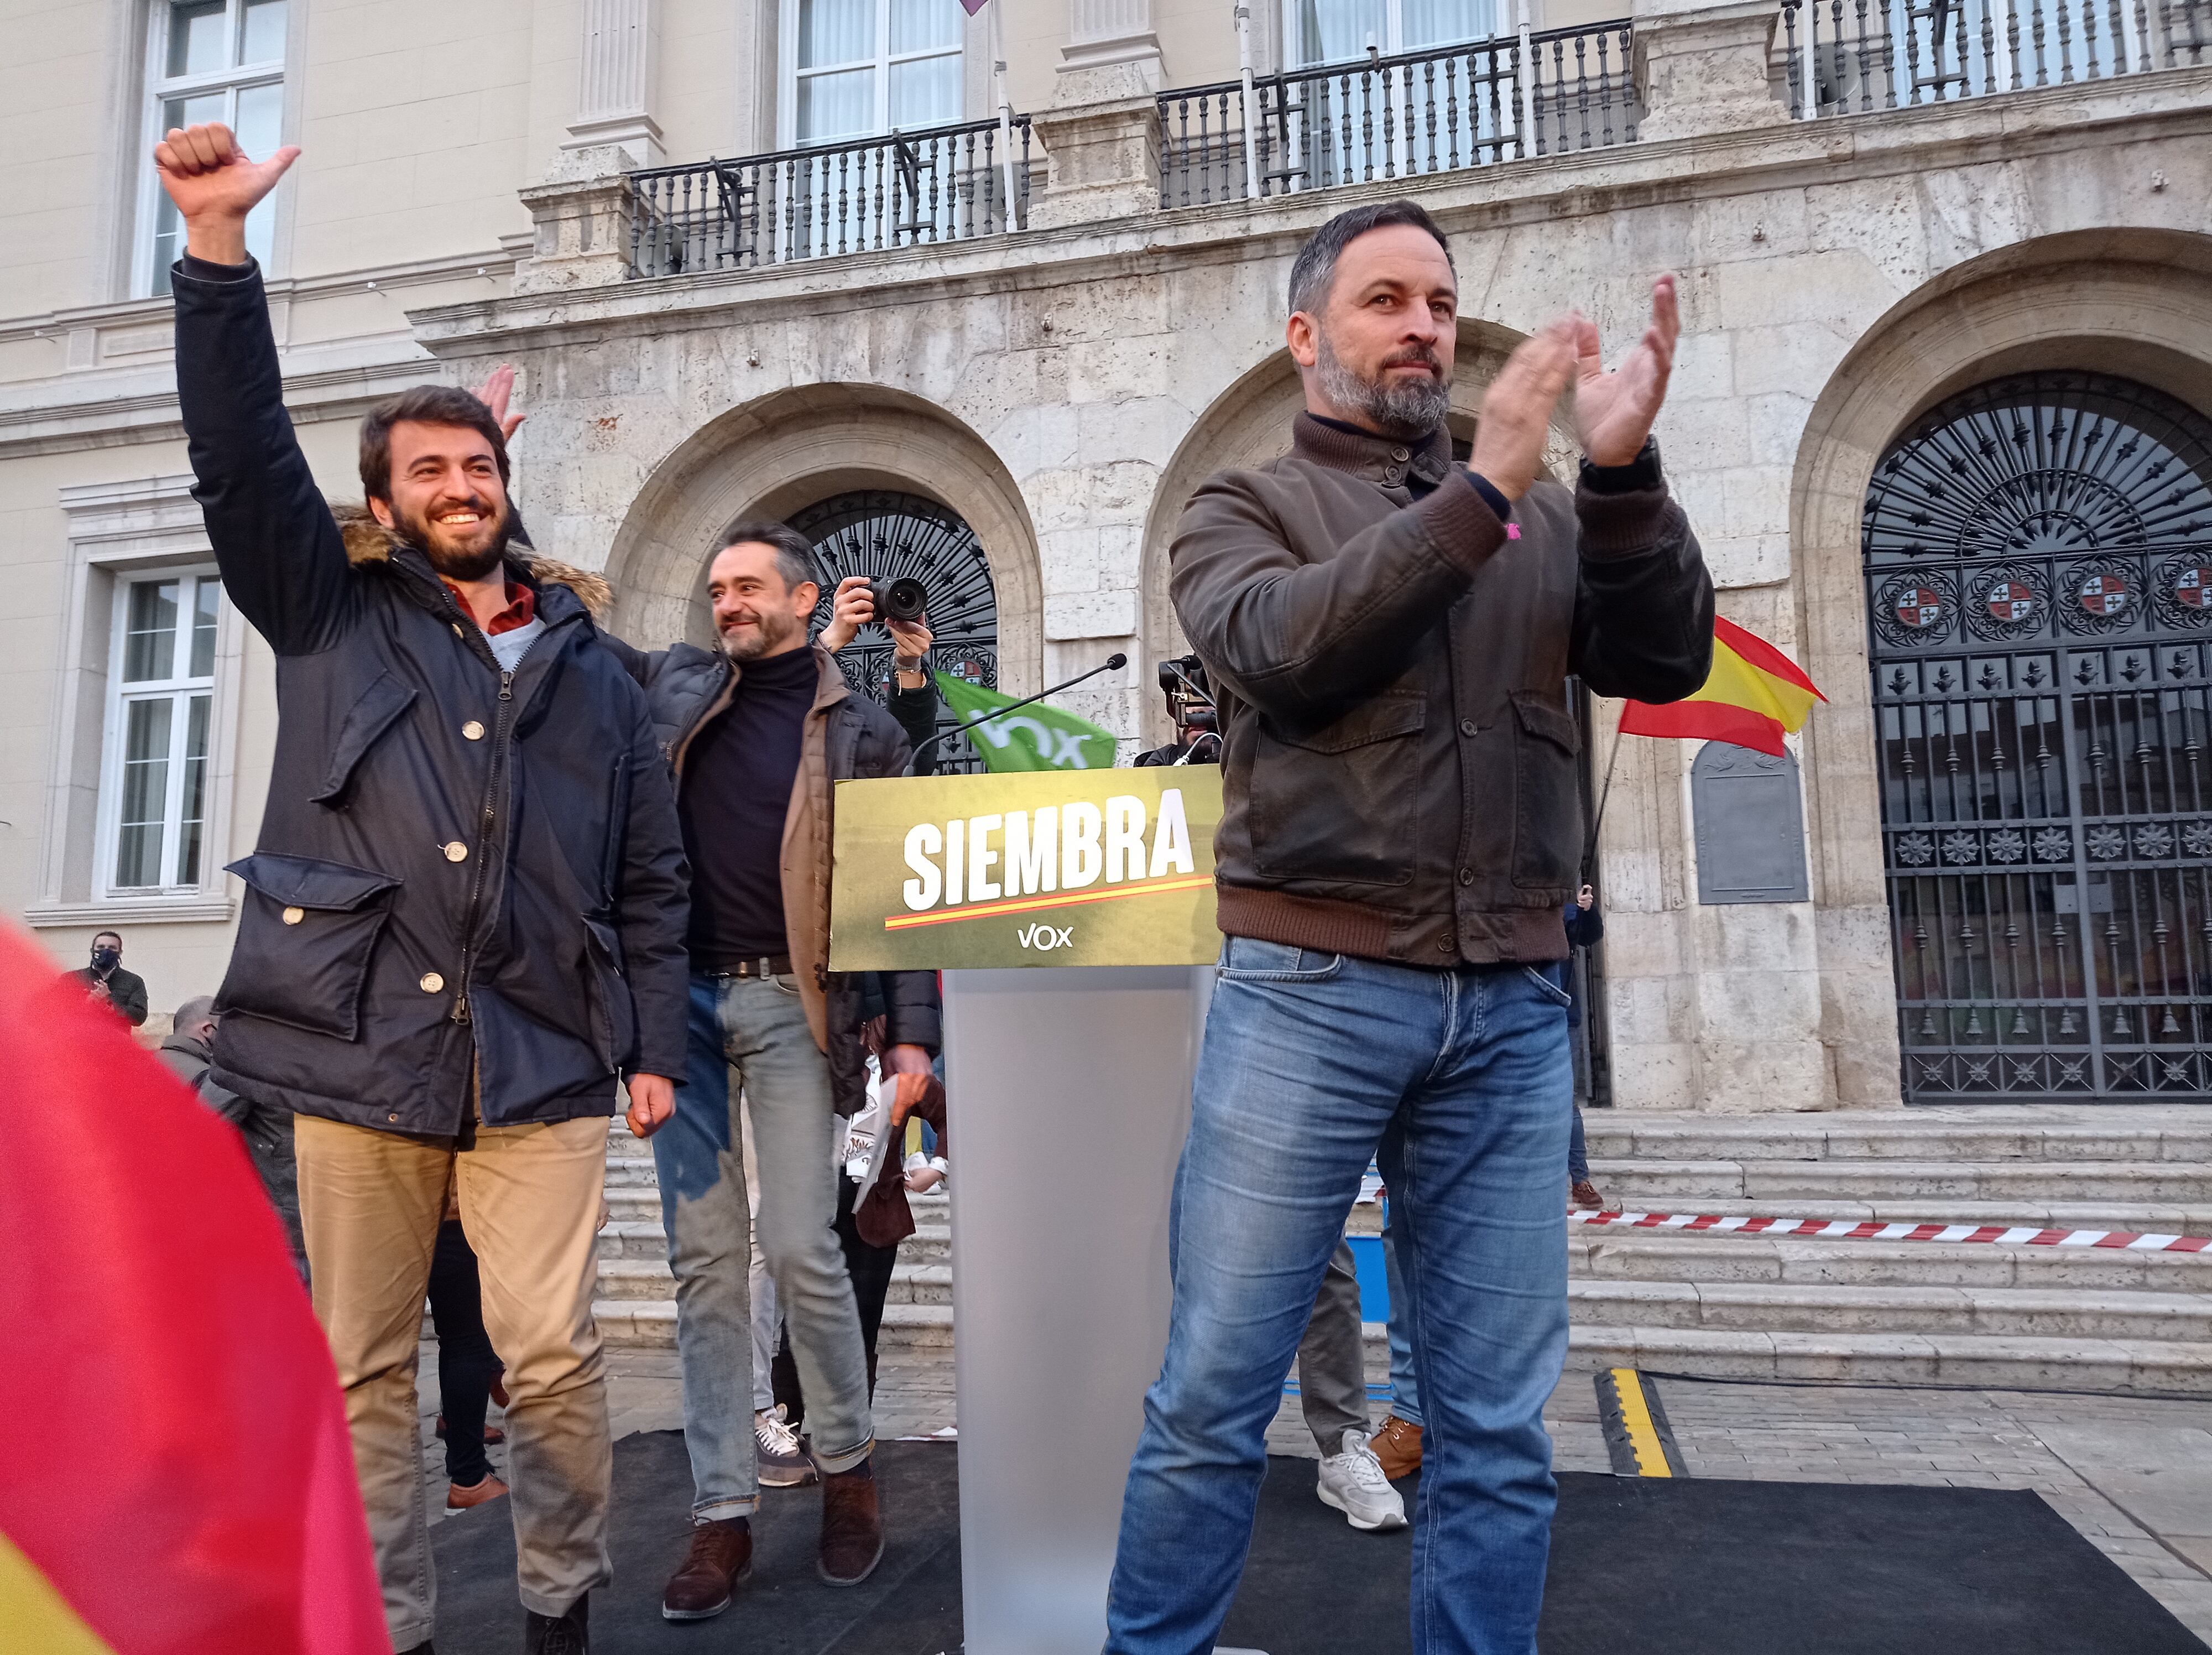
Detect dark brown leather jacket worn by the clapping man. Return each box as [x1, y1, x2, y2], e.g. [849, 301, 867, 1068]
[1168, 414, 1712, 967]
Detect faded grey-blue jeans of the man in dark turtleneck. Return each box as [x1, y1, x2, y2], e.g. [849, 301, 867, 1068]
[650, 976, 876, 1522]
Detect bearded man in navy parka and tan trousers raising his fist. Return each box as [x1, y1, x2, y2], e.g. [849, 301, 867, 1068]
[155, 124, 690, 1655]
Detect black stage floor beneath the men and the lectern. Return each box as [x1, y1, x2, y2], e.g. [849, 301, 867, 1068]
[431, 1432, 2205, 1655]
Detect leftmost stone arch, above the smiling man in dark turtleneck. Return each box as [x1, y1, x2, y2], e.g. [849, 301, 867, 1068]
[606, 385, 1044, 695]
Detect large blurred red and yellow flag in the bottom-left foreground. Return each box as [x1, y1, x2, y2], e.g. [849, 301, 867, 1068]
[0, 929, 392, 1655]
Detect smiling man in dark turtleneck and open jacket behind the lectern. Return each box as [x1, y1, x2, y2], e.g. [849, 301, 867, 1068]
[602, 520, 938, 1620]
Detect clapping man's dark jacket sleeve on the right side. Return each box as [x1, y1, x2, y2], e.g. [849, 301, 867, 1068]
[1568, 473, 1712, 701]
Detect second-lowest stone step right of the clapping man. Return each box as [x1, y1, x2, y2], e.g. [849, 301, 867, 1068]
[1566, 1279, 2212, 1345]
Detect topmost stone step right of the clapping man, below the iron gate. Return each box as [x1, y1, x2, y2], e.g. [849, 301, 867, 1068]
[1582, 1104, 2212, 1162]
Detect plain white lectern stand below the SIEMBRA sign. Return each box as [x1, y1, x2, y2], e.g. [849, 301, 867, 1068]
[945, 965, 1212, 1655]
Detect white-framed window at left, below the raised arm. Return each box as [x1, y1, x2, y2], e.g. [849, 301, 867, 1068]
[102, 575, 223, 896]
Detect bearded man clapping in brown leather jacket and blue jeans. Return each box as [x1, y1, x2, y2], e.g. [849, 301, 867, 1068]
[1106, 201, 1712, 1655]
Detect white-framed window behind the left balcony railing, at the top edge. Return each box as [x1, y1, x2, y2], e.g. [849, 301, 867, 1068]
[792, 0, 964, 144]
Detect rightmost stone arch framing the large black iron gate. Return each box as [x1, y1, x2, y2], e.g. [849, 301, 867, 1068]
[1790, 230, 2212, 1097]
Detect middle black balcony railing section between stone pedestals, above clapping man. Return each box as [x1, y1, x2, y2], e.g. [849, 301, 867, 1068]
[1159, 21, 1637, 208]
